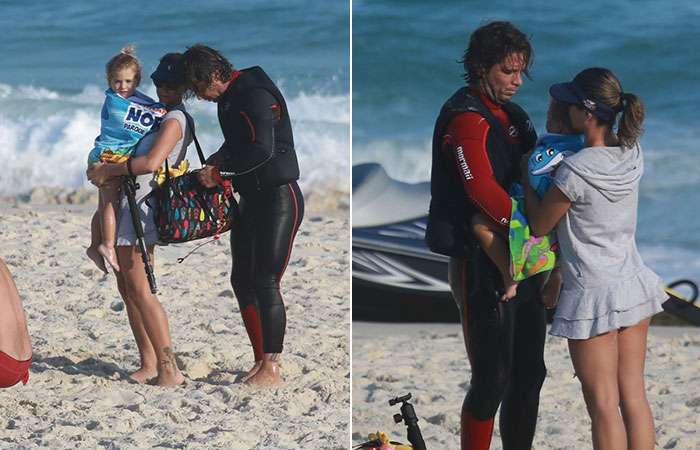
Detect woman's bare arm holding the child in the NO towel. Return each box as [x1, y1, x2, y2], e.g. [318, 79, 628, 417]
[88, 119, 182, 186]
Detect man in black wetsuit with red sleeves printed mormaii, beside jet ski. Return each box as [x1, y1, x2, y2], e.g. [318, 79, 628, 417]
[426, 22, 546, 450]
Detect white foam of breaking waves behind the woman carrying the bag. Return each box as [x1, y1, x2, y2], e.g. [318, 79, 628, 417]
[0, 84, 350, 207]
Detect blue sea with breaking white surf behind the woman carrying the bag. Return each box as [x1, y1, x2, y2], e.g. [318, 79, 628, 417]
[0, 0, 350, 206]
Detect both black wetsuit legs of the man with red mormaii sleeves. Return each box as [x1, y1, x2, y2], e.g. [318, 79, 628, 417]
[449, 251, 546, 450]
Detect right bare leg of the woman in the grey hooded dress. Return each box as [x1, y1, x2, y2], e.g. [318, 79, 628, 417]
[617, 318, 656, 450]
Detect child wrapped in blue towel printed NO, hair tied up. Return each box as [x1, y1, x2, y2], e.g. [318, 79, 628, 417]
[86, 45, 167, 273]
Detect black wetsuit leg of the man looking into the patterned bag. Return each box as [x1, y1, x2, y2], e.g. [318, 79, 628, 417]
[231, 182, 304, 353]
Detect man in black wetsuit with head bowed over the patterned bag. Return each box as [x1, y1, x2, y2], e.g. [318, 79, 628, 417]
[178, 44, 304, 388]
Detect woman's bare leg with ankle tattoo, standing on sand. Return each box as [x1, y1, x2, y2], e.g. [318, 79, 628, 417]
[118, 245, 185, 386]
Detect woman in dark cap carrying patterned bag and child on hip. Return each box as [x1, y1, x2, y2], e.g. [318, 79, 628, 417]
[88, 53, 193, 386]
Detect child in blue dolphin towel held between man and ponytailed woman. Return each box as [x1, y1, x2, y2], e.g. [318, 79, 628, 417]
[472, 99, 583, 308]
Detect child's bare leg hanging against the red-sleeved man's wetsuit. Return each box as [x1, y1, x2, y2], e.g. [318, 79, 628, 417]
[472, 214, 519, 302]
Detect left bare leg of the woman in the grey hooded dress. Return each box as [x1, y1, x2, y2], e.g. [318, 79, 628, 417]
[569, 330, 631, 450]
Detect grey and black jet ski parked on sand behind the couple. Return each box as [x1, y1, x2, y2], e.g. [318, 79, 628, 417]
[352, 163, 700, 326]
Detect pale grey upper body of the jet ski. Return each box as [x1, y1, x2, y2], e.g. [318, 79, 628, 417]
[352, 163, 430, 228]
